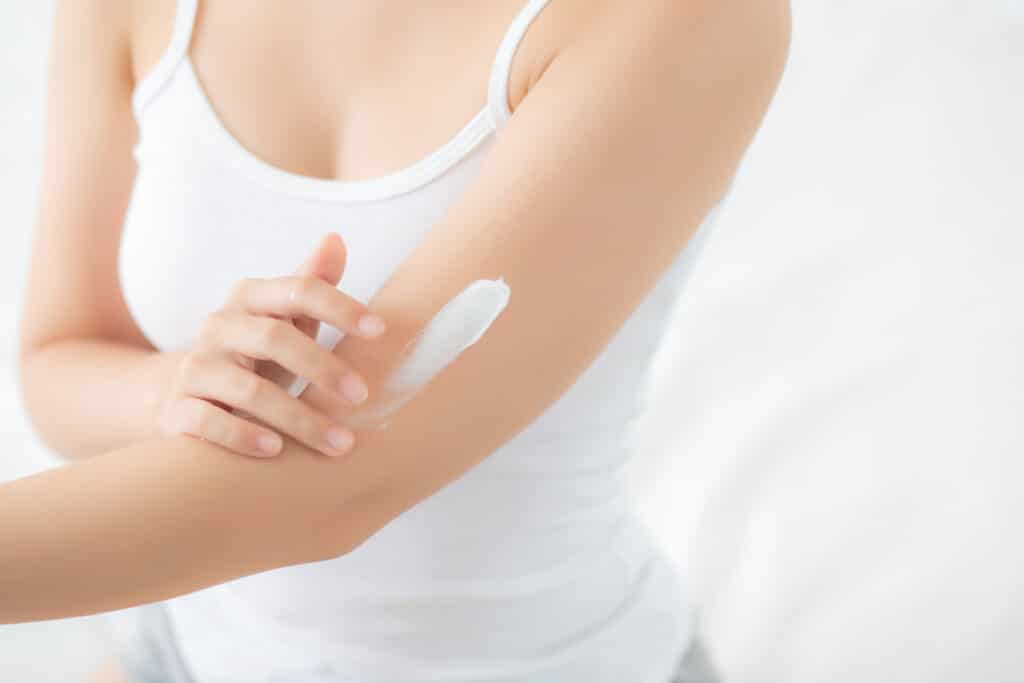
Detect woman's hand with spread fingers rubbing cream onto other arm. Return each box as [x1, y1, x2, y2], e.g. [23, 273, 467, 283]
[158, 233, 384, 457]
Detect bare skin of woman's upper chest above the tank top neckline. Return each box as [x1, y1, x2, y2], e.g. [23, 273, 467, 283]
[132, 0, 570, 180]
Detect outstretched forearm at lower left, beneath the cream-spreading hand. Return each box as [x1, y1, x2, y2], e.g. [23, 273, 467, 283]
[0, 436, 346, 623]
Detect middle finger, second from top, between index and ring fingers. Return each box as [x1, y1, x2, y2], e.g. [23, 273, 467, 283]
[201, 311, 370, 405]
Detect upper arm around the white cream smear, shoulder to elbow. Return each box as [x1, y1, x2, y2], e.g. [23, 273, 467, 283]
[296, 0, 790, 548]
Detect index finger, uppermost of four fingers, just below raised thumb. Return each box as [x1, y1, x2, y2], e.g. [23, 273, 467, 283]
[229, 275, 385, 339]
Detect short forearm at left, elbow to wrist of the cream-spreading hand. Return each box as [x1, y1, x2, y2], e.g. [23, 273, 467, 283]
[20, 339, 180, 460]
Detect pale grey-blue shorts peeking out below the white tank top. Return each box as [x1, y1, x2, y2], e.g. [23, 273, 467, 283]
[117, 602, 722, 683]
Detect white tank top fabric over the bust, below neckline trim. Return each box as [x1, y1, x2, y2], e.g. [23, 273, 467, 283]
[118, 139, 487, 351]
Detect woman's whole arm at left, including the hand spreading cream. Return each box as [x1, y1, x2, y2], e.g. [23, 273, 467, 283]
[19, 0, 379, 460]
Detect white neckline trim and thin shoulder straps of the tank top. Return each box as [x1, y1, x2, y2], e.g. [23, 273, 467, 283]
[132, 0, 550, 202]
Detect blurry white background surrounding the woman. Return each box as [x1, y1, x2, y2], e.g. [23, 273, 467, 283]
[0, 0, 1024, 683]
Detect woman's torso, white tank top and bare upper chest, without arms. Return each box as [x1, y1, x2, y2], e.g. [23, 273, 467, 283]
[119, 0, 711, 683]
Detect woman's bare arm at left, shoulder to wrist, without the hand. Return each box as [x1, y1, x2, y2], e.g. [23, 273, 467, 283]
[19, 0, 180, 459]
